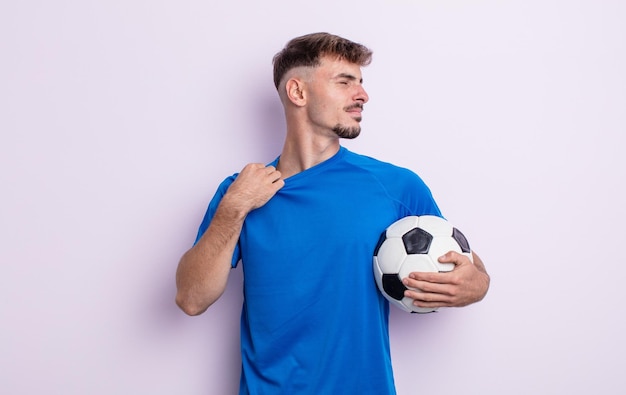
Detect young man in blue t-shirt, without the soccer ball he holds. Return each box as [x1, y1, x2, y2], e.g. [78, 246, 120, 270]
[176, 33, 489, 395]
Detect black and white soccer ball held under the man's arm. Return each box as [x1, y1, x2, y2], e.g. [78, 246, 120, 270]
[373, 215, 472, 313]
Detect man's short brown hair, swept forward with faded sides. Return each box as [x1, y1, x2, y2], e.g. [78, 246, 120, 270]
[273, 33, 372, 89]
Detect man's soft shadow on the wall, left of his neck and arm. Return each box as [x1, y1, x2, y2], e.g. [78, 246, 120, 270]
[140, 85, 285, 393]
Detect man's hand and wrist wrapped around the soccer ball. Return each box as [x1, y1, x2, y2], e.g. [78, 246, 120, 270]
[403, 252, 491, 307]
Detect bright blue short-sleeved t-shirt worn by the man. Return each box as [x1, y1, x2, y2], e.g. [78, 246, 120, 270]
[198, 147, 440, 395]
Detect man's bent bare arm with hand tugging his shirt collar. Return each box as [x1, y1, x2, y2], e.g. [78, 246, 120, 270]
[176, 163, 285, 315]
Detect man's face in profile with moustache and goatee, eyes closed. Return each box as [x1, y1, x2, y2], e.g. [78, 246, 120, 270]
[307, 57, 369, 139]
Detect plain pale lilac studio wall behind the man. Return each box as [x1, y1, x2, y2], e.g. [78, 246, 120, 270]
[0, 0, 626, 395]
